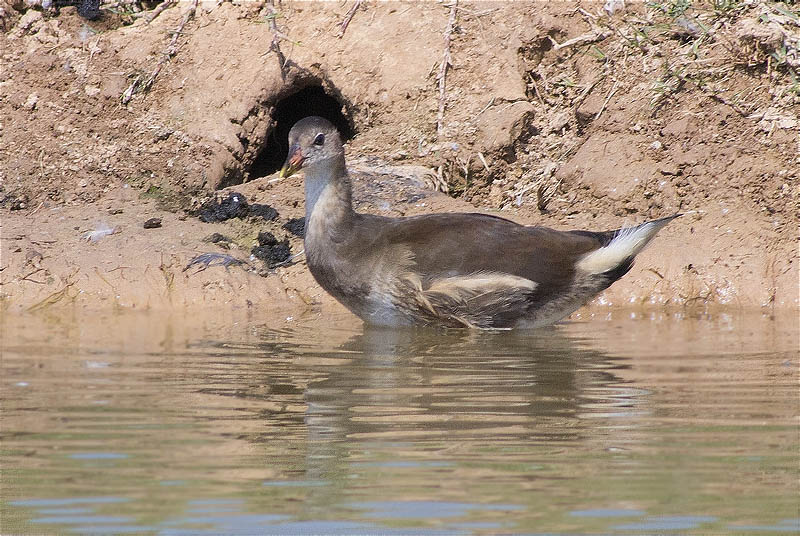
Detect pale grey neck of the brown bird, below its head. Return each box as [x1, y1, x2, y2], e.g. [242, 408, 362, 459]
[305, 158, 354, 238]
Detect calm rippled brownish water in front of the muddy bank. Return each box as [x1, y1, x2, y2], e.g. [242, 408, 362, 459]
[0, 312, 800, 535]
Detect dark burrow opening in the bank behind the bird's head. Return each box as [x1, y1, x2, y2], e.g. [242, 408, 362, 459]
[249, 85, 355, 179]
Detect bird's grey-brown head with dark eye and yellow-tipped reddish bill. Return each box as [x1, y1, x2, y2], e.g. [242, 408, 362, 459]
[280, 117, 344, 177]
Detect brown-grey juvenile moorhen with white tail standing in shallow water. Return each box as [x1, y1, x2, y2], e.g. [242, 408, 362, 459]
[280, 116, 680, 329]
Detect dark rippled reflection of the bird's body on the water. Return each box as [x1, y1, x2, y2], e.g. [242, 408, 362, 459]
[282, 327, 634, 505]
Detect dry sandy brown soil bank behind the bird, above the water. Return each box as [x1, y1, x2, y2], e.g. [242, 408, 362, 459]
[0, 0, 800, 314]
